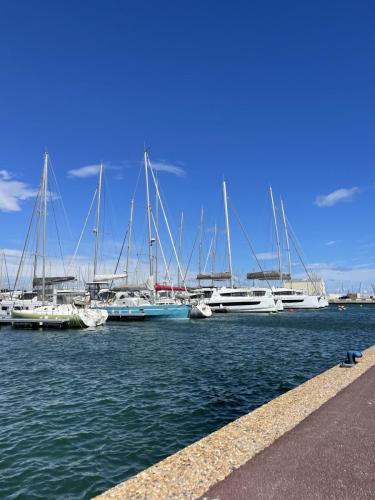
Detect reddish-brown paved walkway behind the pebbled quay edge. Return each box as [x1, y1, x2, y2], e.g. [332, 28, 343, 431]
[202, 367, 375, 500]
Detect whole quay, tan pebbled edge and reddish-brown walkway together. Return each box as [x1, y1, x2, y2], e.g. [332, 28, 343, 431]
[97, 346, 375, 500]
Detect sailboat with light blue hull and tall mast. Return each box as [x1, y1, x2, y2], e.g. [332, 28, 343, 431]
[94, 149, 191, 320]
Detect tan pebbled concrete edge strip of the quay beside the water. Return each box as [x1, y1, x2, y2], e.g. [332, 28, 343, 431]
[95, 346, 375, 500]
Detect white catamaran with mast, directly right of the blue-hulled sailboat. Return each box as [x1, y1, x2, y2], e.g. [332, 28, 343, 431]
[203, 181, 279, 313]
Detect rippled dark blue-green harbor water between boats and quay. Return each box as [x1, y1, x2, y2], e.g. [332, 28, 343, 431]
[0, 306, 375, 499]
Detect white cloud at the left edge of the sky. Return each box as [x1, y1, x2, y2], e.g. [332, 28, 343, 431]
[0, 170, 38, 212]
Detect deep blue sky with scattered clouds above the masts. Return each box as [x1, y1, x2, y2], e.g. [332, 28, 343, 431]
[0, 0, 375, 291]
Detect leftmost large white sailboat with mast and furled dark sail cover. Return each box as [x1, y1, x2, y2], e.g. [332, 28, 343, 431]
[11, 152, 108, 328]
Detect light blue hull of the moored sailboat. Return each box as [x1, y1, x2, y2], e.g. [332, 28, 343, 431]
[101, 304, 191, 320]
